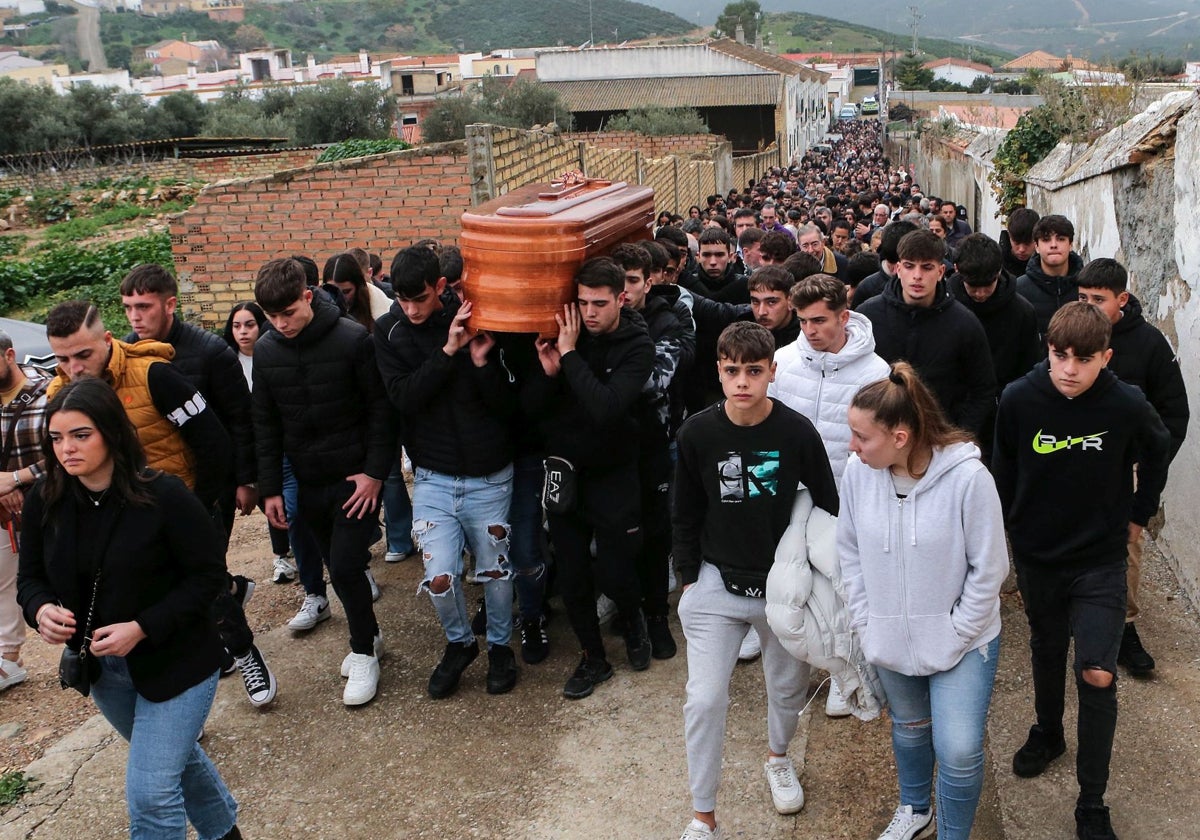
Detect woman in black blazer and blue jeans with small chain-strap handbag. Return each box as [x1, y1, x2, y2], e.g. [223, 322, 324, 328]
[17, 378, 241, 840]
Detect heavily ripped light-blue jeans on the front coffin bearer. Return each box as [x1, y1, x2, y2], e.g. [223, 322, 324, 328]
[413, 464, 512, 644]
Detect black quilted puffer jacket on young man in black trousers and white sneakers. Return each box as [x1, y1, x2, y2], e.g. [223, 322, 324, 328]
[252, 295, 396, 496]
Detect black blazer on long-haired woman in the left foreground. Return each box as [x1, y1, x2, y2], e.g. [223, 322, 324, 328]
[17, 473, 226, 702]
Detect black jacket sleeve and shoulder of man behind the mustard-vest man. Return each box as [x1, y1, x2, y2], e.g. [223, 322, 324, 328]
[133, 317, 258, 485]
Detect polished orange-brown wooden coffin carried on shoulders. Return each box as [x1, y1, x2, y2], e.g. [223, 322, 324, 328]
[460, 178, 654, 337]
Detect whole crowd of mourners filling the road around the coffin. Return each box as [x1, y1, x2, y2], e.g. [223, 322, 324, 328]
[0, 121, 1188, 840]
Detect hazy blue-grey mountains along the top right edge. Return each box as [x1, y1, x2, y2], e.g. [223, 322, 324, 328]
[647, 0, 1200, 61]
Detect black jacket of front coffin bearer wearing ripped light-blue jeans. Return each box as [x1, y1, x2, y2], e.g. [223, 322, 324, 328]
[374, 293, 516, 476]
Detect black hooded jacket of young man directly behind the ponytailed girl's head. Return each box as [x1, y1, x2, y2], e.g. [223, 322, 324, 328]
[859, 278, 997, 436]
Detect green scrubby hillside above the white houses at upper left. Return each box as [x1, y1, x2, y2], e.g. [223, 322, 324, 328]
[87, 0, 695, 66]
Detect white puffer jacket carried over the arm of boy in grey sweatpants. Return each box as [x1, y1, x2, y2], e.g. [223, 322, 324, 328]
[767, 487, 883, 720]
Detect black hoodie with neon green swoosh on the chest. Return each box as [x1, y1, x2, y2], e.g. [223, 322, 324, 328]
[991, 361, 1171, 566]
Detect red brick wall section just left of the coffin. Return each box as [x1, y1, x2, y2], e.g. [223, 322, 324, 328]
[170, 143, 470, 326]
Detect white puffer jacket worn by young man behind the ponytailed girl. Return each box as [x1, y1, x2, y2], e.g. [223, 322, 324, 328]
[767, 312, 889, 485]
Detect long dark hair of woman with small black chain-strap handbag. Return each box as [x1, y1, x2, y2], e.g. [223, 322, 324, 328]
[42, 377, 158, 522]
